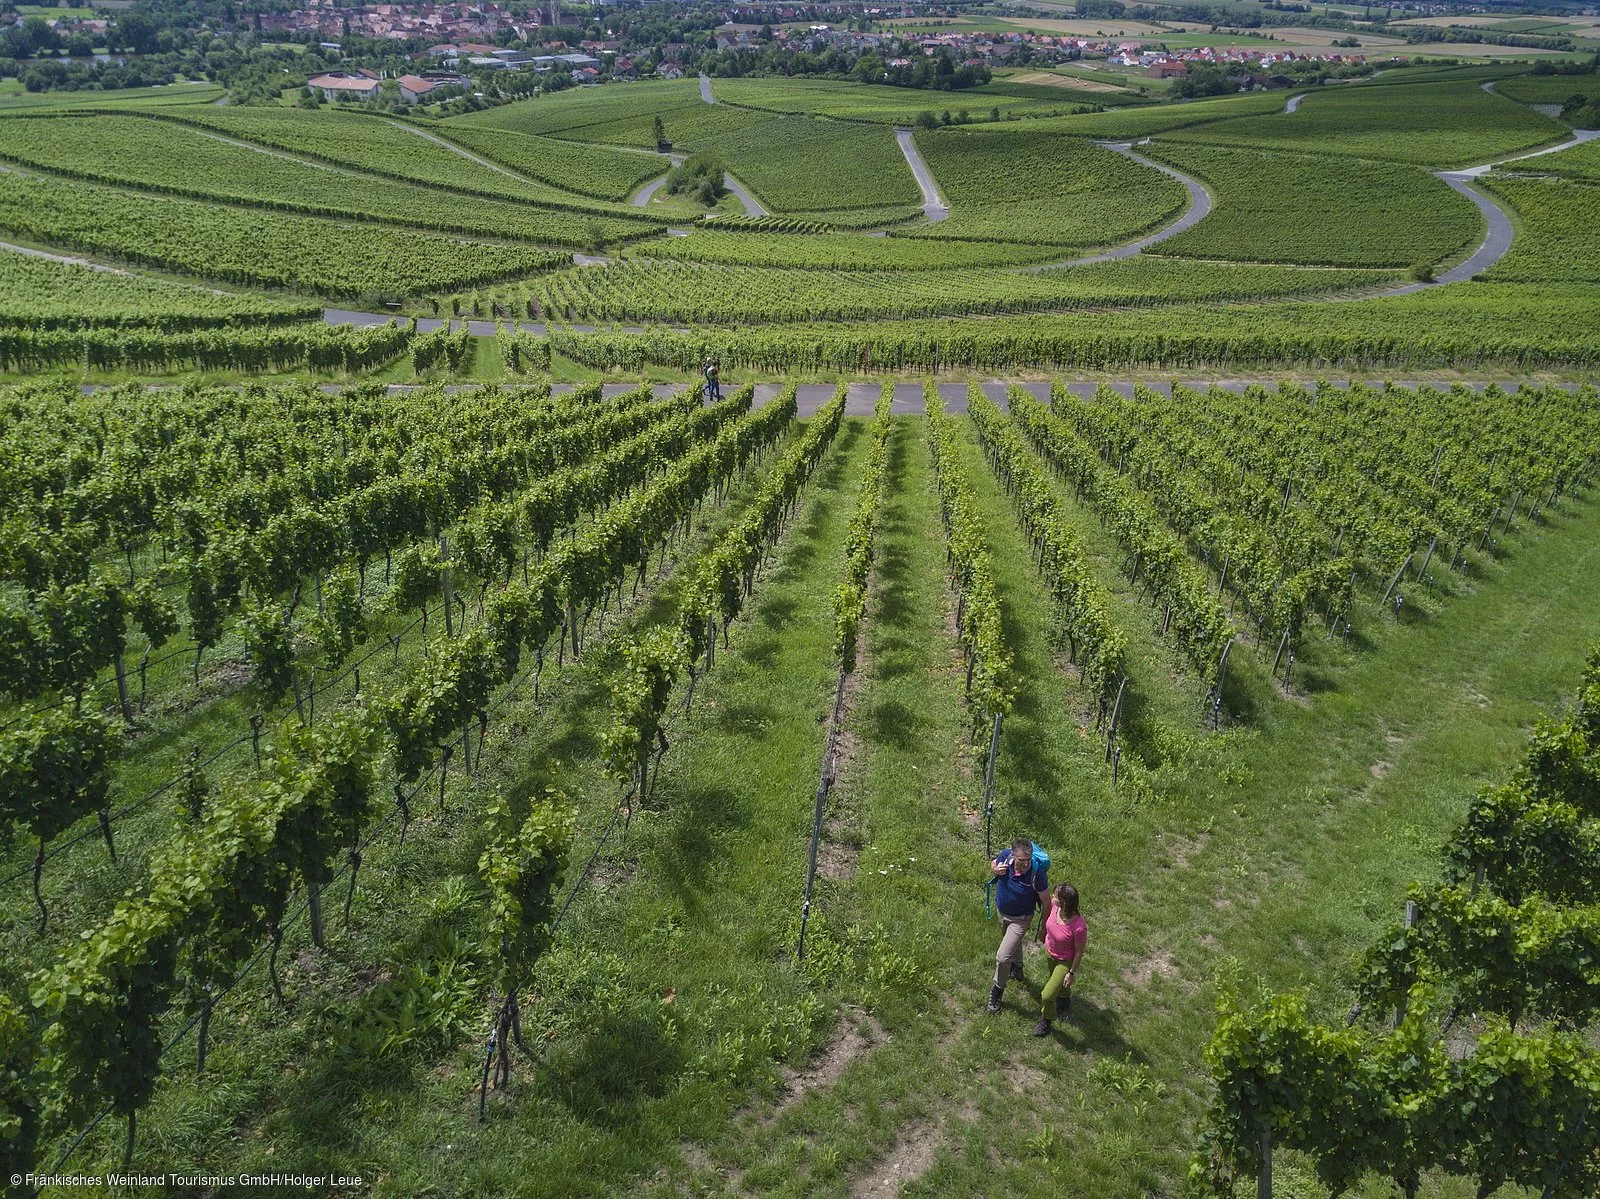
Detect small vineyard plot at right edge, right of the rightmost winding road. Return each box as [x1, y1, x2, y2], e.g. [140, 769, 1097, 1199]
[1483, 174, 1600, 283]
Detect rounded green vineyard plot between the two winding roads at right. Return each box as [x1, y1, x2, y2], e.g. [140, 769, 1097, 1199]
[1142, 141, 1483, 266]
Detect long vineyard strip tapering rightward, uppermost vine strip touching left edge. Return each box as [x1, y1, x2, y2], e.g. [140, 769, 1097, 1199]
[0, 114, 659, 247]
